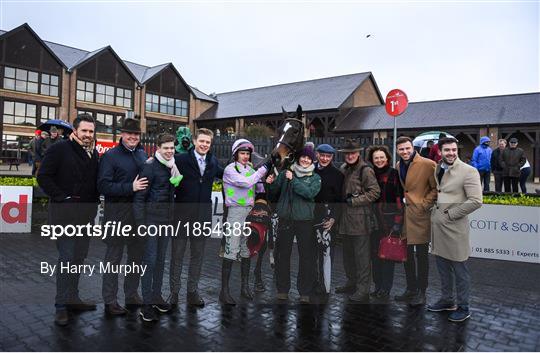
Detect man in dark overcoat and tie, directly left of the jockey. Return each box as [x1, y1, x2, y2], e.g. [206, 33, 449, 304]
[169, 129, 223, 307]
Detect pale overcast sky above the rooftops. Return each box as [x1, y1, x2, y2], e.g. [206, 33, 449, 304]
[0, 0, 540, 102]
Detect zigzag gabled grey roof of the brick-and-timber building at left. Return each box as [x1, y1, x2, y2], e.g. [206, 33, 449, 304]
[0, 23, 215, 102]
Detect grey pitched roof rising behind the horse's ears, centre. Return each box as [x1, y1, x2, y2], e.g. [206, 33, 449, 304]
[199, 72, 382, 119]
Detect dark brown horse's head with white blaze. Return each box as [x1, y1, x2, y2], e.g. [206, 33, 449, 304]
[271, 105, 304, 171]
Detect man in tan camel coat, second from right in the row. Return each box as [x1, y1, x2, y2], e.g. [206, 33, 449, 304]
[395, 136, 437, 306]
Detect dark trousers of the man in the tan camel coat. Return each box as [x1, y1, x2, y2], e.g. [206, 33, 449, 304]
[404, 244, 429, 292]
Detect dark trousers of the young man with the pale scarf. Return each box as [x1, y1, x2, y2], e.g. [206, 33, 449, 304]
[141, 236, 169, 304]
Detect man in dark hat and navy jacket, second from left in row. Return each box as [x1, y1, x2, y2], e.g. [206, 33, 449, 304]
[98, 119, 148, 315]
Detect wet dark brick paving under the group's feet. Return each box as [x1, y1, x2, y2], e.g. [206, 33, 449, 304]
[0, 234, 540, 351]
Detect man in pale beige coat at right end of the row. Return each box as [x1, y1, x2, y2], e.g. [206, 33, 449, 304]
[428, 138, 482, 322]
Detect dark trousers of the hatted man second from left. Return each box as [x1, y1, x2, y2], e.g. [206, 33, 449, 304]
[101, 237, 146, 304]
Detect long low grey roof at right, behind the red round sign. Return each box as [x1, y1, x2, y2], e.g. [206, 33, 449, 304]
[334, 92, 540, 132]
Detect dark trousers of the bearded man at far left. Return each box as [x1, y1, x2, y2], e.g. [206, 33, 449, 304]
[55, 236, 90, 309]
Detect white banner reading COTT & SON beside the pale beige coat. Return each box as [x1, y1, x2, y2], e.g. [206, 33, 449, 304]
[469, 205, 540, 263]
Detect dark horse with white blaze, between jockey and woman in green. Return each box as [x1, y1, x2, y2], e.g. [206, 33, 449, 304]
[254, 105, 305, 292]
